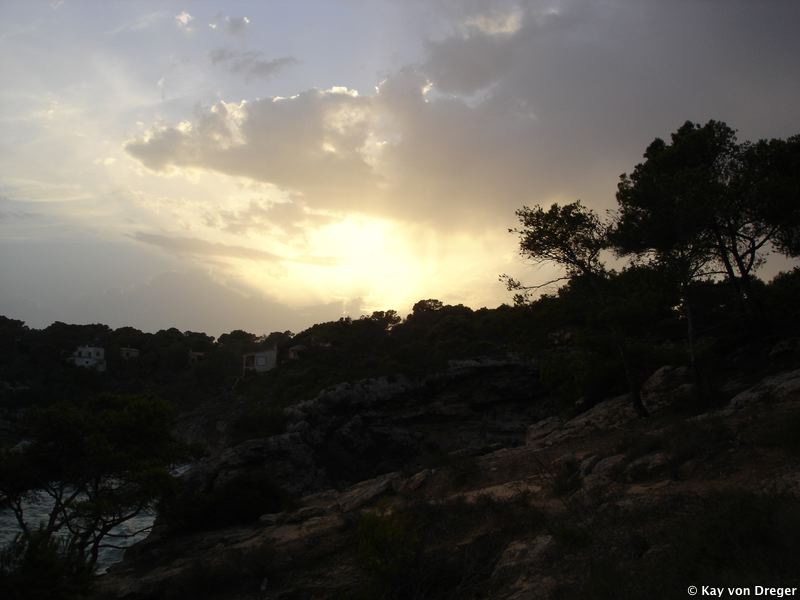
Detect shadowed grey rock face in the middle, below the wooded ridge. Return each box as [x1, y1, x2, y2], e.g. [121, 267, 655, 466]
[184, 361, 549, 506]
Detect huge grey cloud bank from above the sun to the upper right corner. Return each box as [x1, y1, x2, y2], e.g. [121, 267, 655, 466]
[126, 0, 800, 231]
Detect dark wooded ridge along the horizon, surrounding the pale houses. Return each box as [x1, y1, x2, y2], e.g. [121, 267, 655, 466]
[0, 300, 528, 408]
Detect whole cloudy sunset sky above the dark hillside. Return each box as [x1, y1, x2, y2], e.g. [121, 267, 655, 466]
[0, 0, 800, 335]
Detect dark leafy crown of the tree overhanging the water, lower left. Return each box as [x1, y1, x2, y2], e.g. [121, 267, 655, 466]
[0, 395, 181, 567]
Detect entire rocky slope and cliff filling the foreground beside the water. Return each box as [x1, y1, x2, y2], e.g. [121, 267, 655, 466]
[98, 363, 800, 600]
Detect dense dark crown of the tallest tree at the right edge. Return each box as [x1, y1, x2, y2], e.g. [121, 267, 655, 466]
[611, 120, 800, 300]
